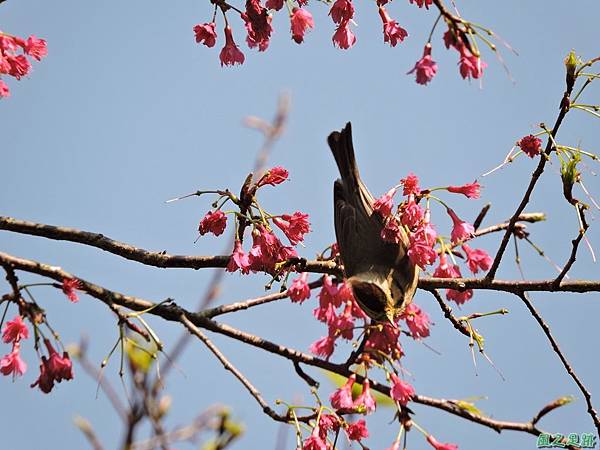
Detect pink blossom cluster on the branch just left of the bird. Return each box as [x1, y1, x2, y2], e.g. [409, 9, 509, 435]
[198, 167, 310, 275]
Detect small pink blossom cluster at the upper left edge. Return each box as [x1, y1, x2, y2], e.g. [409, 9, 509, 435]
[0, 31, 48, 98]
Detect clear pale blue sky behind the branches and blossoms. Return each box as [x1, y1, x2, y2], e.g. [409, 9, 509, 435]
[0, 0, 600, 450]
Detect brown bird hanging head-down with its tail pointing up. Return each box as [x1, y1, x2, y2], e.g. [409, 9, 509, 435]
[327, 122, 419, 327]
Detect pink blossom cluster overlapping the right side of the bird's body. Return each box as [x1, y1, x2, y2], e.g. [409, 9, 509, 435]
[374, 174, 492, 304]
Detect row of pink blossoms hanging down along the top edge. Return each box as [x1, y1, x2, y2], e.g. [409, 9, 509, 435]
[194, 0, 496, 84]
